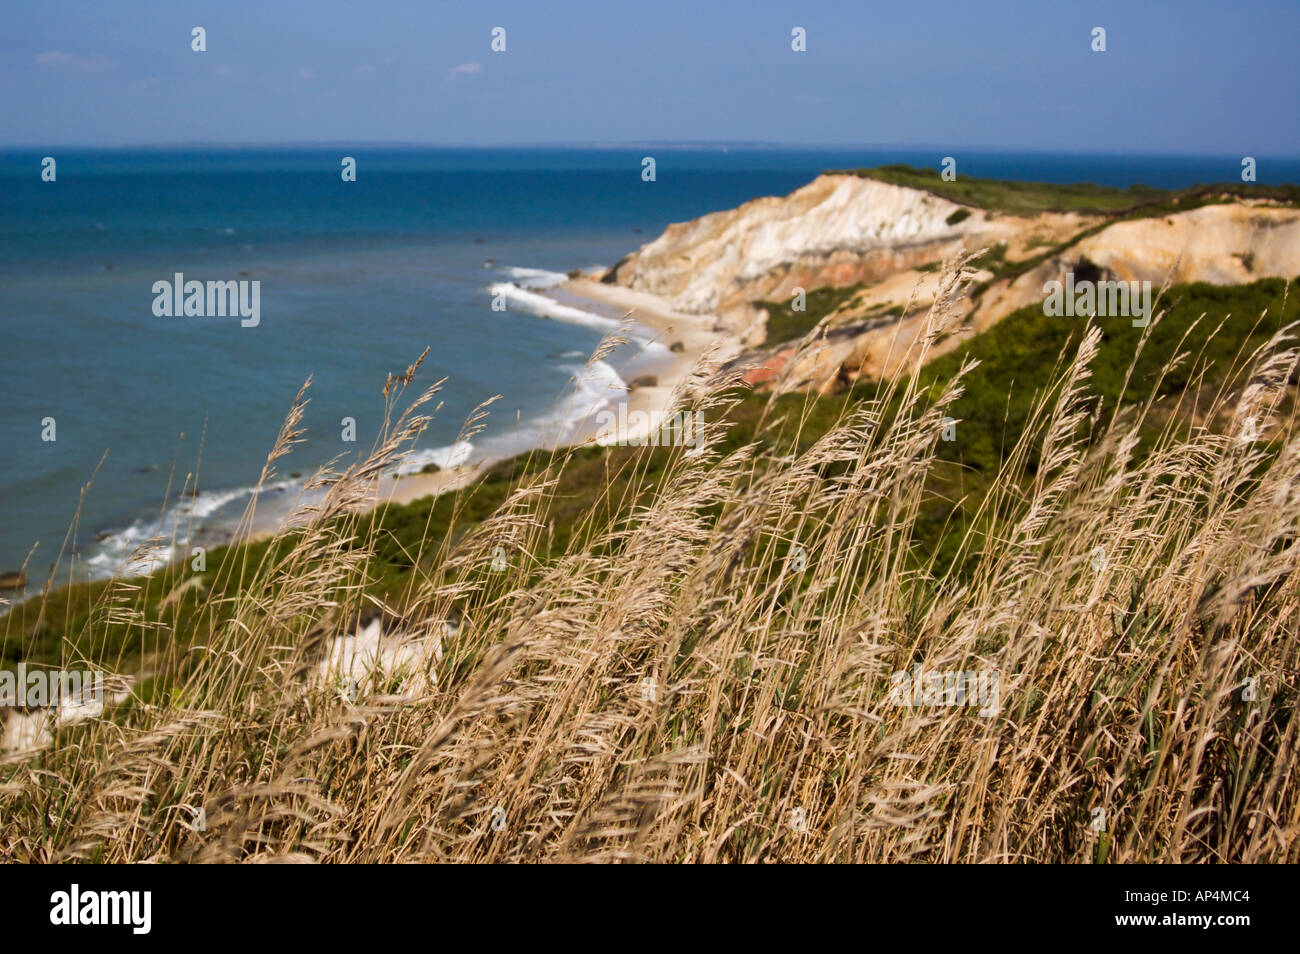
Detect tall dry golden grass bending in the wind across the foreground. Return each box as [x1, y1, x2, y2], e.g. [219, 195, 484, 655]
[0, 256, 1300, 862]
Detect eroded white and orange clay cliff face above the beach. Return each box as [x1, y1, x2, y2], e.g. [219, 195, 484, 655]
[603, 174, 1300, 390]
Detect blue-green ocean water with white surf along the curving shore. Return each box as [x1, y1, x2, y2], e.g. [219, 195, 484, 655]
[0, 147, 1300, 578]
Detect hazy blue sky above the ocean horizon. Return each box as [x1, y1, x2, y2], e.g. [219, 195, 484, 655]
[0, 0, 1300, 157]
